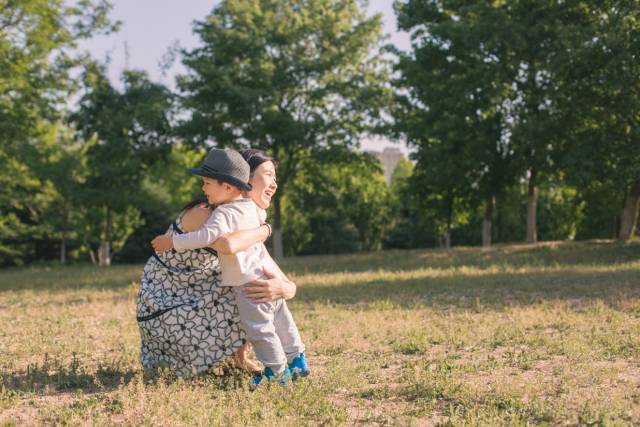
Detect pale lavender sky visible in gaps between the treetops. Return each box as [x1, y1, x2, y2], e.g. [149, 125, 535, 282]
[80, 0, 410, 153]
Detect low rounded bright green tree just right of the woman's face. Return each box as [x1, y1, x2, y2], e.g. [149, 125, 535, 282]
[283, 148, 393, 254]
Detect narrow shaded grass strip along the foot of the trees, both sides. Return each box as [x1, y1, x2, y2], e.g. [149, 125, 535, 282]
[0, 241, 640, 294]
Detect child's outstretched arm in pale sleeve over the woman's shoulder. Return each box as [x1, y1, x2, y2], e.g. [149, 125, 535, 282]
[151, 207, 231, 252]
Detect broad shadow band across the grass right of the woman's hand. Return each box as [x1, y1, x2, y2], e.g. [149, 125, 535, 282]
[296, 269, 640, 310]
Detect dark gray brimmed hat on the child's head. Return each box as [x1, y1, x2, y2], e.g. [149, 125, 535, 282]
[187, 148, 251, 191]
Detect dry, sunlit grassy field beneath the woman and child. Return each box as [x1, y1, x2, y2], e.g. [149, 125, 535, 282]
[0, 242, 640, 426]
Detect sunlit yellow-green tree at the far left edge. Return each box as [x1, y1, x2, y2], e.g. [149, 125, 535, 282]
[0, 0, 116, 263]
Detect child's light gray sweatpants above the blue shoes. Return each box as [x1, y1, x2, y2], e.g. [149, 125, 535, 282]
[233, 286, 304, 374]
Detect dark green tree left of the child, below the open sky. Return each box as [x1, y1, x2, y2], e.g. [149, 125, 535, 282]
[71, 63, 173, 265]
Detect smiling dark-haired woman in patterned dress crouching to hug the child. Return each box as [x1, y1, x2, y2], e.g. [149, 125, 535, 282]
[137, 150, 296, 376]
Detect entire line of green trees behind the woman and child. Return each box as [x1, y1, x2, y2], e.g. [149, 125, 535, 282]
[0, 0, 640, 265]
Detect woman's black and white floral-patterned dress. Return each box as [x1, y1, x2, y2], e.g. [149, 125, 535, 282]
[136, 212, 245, 376]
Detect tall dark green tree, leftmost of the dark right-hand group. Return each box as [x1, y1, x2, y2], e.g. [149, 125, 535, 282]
[392, 1, 515, 247]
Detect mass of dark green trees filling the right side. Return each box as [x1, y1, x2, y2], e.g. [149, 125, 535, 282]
[391, 0, 640, 249]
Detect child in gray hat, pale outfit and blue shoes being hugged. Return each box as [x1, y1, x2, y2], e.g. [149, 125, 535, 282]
[151, 149, 310, 387]
